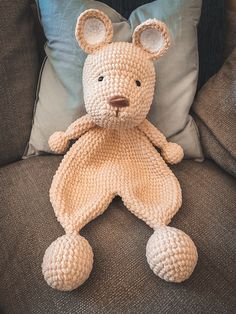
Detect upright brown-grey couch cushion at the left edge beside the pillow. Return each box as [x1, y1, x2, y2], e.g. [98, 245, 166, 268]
[0, 0, 38, 165]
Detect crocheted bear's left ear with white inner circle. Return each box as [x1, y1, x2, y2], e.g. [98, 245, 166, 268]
[75, 9, 113, 53]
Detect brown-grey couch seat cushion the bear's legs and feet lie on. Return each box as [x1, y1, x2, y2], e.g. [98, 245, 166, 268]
[0, 156, 236, 314]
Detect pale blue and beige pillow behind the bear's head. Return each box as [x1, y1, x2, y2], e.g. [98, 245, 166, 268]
[26, 0, 202, 159]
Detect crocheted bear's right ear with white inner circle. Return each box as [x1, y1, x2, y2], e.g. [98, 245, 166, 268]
[133, 19, 170, 60]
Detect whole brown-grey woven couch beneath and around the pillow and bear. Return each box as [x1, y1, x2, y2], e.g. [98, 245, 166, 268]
[0, 0, 236, 314]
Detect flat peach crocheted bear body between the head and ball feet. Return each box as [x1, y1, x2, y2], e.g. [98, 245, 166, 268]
[50, 122, 183, 232]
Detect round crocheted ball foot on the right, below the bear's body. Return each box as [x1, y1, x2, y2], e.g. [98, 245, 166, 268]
[146, 226, 198, 282]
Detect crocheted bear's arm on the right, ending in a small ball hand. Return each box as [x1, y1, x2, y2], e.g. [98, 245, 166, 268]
[138, 119, 184, 164]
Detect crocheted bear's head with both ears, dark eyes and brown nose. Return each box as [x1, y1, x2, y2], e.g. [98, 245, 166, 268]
[75, 10, 170, 129]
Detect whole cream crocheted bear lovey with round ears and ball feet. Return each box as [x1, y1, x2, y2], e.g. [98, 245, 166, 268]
[42, 10, 197, 290]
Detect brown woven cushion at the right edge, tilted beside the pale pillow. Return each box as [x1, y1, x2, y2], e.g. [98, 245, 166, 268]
[193, 48, 236, 175]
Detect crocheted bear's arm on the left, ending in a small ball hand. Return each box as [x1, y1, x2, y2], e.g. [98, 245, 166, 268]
[48, 114, 95, 154]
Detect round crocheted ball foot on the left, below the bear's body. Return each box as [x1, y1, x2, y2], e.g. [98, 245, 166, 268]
[42, 234, 93, 291]
